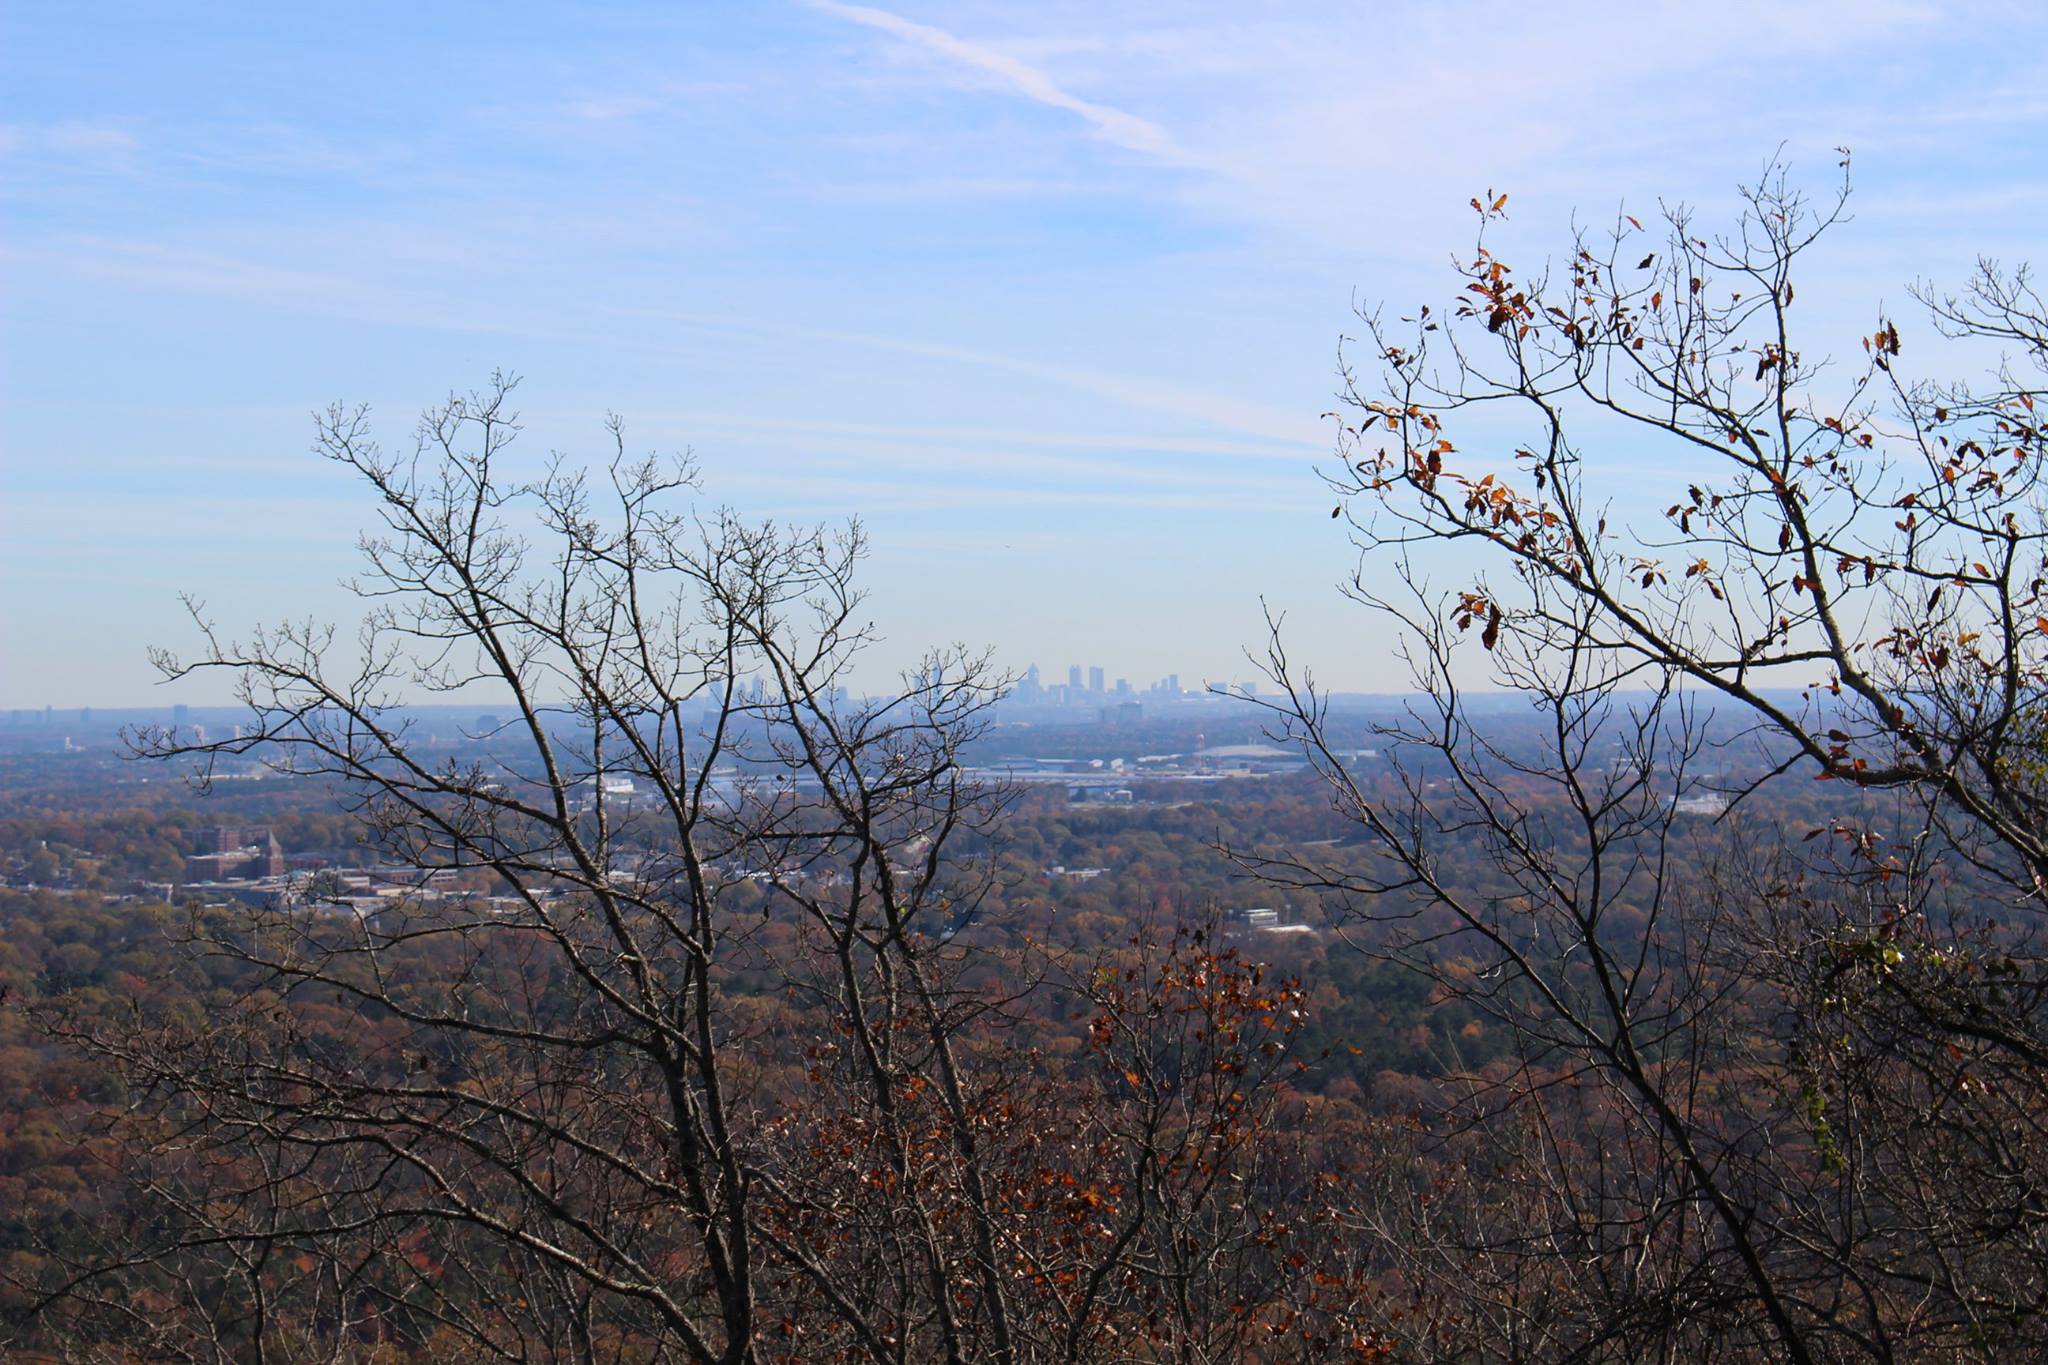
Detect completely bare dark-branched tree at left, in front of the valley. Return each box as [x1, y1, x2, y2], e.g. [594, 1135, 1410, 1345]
[24, 379, 1012, 1361]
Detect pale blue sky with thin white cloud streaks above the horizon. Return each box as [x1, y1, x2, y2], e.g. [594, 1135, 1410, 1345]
[0, 0, 2048, 706]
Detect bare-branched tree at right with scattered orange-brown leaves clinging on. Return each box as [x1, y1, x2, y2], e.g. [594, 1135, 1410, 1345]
[1236, 166, 2048, 1361]
